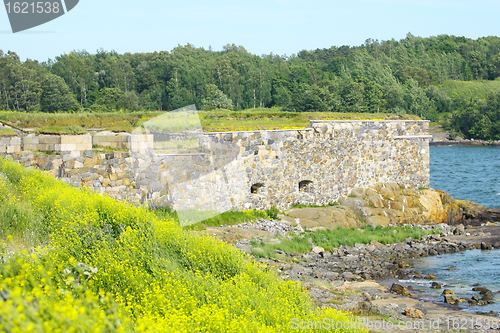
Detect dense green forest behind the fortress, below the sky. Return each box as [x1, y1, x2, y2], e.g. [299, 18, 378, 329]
[0, 34, 500, 140]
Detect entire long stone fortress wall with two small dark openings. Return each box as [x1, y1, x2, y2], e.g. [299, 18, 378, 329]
[0, 120, 430, 212]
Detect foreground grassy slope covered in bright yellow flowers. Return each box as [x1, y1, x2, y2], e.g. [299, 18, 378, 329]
[0, 159, 370, 332]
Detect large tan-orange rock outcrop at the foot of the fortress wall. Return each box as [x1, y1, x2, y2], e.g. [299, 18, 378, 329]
[280, 183, 490, 230]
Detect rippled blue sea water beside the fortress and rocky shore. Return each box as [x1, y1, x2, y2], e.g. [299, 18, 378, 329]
[392, 146, 500, 313]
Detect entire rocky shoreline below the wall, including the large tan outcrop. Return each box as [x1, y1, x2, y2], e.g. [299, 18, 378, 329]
[203, 183, 500, 332]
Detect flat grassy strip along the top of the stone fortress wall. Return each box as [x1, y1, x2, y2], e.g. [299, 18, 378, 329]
[0, 108, 422, 134]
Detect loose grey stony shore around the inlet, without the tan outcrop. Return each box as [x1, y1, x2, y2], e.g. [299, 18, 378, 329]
[225, 220, 500, 332]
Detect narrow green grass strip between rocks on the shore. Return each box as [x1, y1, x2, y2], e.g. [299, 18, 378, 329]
[252, 225, 441, 258]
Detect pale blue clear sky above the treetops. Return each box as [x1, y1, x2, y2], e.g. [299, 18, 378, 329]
[0, 0, 500, 61]
